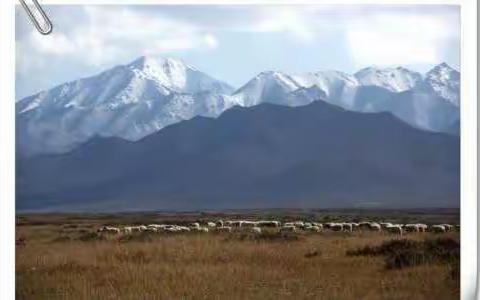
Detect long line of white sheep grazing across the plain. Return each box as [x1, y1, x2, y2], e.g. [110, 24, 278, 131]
[98, 220, 460, 235]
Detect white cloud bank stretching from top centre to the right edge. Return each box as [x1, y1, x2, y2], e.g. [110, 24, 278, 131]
[213, 5, 460, 52]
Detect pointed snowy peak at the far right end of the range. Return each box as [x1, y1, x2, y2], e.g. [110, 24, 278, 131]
[425, 63, 460, 106]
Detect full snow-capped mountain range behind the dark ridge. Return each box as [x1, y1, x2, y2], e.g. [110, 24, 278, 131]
[16, 57, 460, 157]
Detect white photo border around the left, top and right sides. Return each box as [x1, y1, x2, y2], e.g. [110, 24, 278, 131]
[0, 0, 478, 299]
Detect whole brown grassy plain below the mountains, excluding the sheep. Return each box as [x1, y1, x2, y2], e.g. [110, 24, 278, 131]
[16, 210, 460, 299]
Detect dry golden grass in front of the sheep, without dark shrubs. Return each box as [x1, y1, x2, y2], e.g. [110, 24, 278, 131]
[16, 216, 459, 300]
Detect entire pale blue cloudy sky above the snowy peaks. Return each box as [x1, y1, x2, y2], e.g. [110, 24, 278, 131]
[16, 5, 460, 100]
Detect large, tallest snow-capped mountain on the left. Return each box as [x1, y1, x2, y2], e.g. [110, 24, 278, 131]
[16, 57, 238, 154]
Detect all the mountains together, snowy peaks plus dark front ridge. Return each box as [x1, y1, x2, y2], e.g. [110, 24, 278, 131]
[16, 57, 460, 211]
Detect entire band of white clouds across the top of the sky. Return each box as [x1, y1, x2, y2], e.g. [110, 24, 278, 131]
[18, 5, 459, 69]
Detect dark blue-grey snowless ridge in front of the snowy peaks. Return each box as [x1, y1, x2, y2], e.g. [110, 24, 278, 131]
[16, 100, 460, 211]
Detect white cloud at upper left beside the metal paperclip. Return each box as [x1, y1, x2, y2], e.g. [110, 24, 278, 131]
[18, 6, 218, 65]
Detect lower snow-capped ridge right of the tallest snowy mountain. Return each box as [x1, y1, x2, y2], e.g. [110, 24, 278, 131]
[233, 65, 459, 133]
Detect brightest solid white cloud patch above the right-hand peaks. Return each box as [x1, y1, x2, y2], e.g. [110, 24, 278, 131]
[346, 14, 459, 66]
